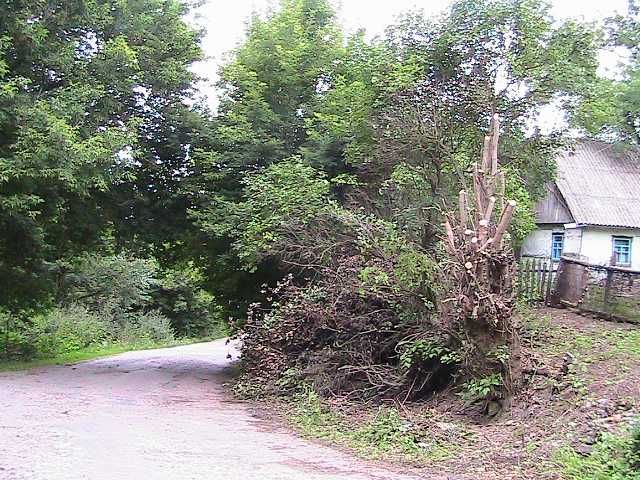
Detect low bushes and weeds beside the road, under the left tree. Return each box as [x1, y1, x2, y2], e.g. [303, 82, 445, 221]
[0, 254, 224, 360]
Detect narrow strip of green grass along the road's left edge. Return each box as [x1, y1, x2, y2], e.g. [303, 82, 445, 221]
[0, 334, 224, 372]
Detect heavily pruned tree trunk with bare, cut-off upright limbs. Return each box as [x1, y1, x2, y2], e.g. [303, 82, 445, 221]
[440, 115, 519, 408]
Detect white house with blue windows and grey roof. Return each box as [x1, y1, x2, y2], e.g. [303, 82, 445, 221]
[521, 141, 640, 270]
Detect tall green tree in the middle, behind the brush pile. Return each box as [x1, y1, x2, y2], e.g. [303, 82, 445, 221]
[191, 0, 342, 316]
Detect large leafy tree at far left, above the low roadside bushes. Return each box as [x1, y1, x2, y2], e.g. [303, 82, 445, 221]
[0, 0, 200, 308]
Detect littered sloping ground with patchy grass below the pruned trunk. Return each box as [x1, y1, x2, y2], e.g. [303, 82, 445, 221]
[258, 309, 640, 480]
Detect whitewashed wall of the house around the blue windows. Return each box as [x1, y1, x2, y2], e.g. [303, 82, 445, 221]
[521, 225, 640, 270]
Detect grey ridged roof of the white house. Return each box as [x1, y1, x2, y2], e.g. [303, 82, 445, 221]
[556, 141, 640, 228]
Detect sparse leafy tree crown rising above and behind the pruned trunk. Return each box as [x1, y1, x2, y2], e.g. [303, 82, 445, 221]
[315, 0, 600, 245]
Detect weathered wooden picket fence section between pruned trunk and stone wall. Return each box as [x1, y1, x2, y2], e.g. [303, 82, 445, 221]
[516, 257, 558, 305]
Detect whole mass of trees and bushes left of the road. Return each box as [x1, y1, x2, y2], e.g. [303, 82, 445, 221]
[0, 0, 220, 358]
